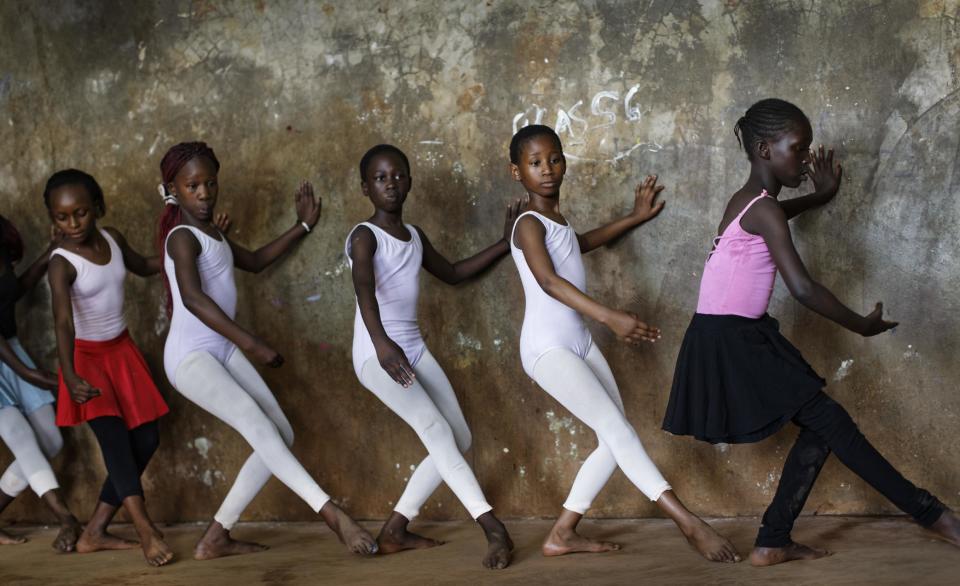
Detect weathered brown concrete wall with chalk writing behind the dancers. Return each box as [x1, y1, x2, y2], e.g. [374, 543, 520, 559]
[0, 0, 960, 520]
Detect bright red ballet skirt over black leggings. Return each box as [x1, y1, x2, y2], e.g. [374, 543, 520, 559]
[57, 330, 170, 429]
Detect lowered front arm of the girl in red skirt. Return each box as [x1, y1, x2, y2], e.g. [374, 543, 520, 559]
[47, 256, 100, 403]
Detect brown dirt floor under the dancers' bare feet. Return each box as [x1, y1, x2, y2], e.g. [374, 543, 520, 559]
[0, 517, 960, 586]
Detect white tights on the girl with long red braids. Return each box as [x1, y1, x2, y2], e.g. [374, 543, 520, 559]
[175, 350, 330, 530]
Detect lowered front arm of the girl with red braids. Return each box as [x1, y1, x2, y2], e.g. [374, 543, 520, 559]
[167, 225, 283, 368]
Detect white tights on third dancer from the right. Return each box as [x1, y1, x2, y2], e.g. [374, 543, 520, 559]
[360, 350, 492, 519]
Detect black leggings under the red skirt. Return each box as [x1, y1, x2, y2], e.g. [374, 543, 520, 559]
[87, 417, 160, 507]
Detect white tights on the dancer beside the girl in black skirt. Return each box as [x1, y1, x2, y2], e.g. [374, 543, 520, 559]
[533, 346, 670, 508]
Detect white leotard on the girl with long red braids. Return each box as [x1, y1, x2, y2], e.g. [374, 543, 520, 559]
[163, 224, 237, 386]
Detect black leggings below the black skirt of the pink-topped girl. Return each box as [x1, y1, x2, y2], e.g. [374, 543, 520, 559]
[756, 392, 946, 547]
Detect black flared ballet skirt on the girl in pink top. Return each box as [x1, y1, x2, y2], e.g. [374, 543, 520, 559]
[663, 313, 827, 444]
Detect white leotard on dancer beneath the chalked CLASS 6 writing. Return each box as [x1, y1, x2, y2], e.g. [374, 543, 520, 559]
[510, 211, 593, 377]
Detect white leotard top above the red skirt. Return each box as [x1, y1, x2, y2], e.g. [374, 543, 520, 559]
[53, 230, 127, 342]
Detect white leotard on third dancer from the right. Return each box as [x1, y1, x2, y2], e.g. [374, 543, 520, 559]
[345, 222, 426, 377]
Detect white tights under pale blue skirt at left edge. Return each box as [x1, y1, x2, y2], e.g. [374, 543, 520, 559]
[0, 405, 63, 497]
